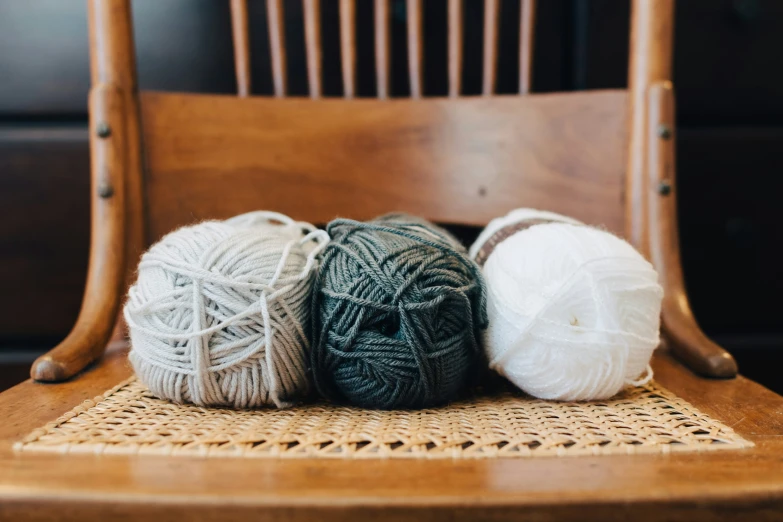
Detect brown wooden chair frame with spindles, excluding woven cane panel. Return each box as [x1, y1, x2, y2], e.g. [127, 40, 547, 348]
[0, 0, 783, 520]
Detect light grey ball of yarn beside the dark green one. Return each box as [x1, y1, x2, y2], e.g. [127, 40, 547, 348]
[123, 212, 329, 408]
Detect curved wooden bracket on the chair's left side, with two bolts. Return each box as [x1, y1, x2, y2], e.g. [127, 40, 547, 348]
[30, 85, 126, 381]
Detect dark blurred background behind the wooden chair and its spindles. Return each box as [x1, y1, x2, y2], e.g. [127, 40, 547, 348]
[0, 0, 783, 392]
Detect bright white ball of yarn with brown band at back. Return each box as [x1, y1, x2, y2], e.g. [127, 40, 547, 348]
[471, 209, 663, 400]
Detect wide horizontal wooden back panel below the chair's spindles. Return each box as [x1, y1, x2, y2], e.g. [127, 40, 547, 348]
[141, 91, 627, 239]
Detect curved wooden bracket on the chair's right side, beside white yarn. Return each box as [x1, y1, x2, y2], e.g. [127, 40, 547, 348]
[647, 82, 737, 378]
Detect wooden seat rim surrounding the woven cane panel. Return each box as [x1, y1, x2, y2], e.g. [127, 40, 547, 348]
[0, 343, 783, 521]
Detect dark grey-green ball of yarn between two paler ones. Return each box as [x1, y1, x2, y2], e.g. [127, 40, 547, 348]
[312, 214, 486, 409]
